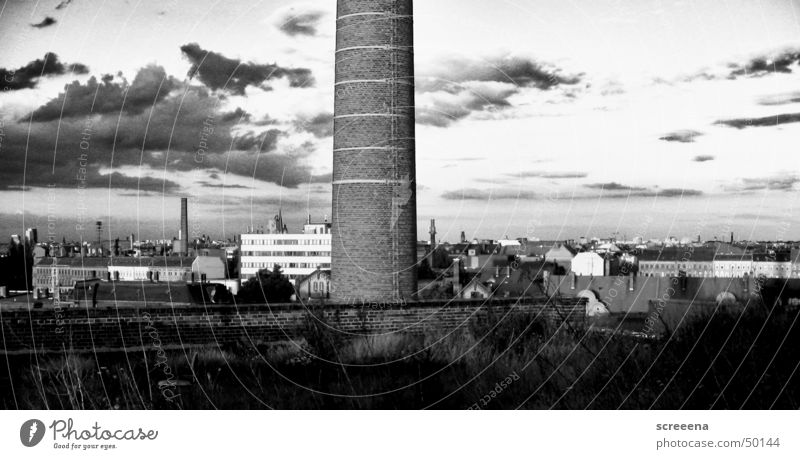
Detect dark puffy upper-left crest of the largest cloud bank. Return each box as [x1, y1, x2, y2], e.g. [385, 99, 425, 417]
[31, 65, 179, 121]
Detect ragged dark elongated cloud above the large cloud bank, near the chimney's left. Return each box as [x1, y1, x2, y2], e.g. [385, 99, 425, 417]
[181, 43, 314, 94]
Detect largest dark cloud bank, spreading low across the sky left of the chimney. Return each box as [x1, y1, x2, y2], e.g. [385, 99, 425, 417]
[0, 67, 330, 192]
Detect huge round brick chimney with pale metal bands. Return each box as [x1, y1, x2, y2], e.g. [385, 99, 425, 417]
[331, 0, 417, 303]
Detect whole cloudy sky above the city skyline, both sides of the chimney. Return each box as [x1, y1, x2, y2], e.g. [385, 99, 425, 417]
[0, 0, 800, 241]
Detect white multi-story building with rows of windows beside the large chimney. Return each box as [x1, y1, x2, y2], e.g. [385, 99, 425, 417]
[239, 218, 331, 284]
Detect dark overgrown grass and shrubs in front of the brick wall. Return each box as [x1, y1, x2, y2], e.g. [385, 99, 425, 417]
[0, 310, 800, 409]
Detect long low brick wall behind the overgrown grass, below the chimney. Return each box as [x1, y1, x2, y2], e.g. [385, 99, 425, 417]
[0, 300, 585, 353]
